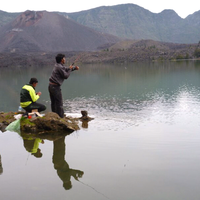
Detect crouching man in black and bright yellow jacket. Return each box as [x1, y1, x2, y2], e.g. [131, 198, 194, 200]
[20, 78, 46, 112]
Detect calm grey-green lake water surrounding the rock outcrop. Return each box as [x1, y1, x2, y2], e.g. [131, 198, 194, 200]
[0, 61, 200, 200]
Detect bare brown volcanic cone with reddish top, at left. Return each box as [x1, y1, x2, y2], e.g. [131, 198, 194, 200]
[0, 11, 119, 52]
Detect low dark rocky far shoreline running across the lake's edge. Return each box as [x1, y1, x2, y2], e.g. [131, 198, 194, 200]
[0, 40, 200, 67]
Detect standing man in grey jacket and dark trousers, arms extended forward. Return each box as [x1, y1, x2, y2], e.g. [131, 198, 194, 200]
[49, 54, 79, 118]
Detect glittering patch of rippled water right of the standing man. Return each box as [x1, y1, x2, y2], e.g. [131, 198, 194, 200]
[64, 86, 200, 129]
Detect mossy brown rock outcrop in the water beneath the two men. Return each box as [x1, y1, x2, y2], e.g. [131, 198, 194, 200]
[0, 111, 93, 135]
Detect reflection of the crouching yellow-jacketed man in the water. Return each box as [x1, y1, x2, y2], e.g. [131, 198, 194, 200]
[23, 137, 44, 158]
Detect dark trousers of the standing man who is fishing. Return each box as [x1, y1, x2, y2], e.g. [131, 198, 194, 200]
[49, 84, 64, 118]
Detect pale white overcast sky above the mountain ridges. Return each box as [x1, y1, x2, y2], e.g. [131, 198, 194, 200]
[0, 0, 200, 18]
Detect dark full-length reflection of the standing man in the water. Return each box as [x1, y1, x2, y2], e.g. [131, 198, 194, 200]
[52, 136, 84, 190]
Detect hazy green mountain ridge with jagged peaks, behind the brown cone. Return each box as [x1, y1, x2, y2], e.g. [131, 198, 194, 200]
[60, 4, 200, 43]
